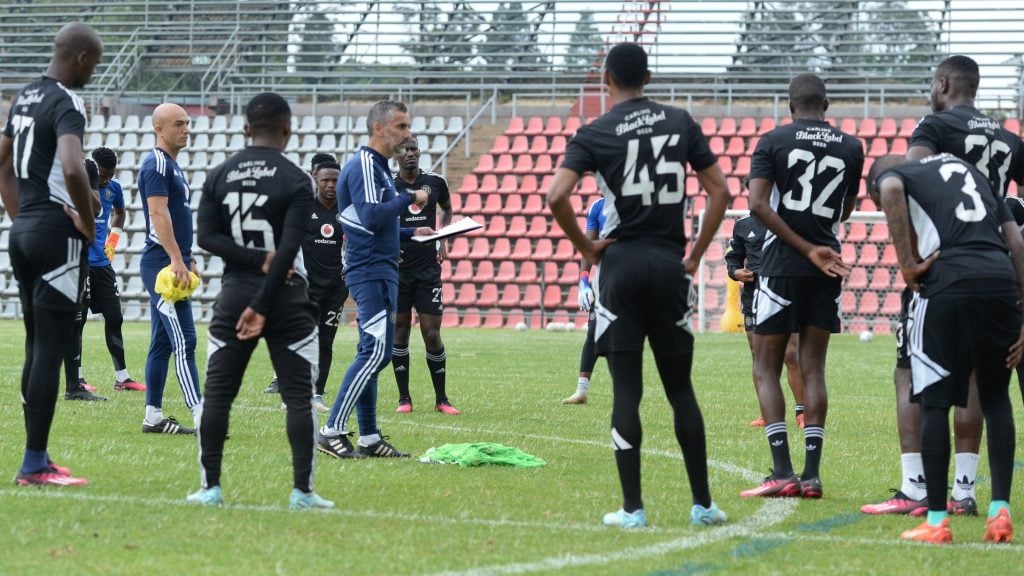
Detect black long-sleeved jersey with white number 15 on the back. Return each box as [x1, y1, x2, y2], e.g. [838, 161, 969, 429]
[198, 146, 313, 316]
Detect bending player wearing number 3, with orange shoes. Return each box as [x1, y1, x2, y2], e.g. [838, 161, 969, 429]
[868, 154, 1024, 543]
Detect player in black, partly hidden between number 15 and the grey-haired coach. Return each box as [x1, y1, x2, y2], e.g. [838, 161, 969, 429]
[302, 160, 348, 412]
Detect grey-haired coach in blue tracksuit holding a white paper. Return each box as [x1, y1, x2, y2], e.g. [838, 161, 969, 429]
[316, 100, 433, 458]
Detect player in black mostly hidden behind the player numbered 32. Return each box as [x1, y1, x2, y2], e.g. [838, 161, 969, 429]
[725, 208, 804, 428]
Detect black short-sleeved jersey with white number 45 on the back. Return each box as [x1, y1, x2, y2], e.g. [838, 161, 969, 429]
[561, 97, 718, 251]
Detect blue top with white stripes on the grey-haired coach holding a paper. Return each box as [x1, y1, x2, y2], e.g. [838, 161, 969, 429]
[338, 147, 413, 286]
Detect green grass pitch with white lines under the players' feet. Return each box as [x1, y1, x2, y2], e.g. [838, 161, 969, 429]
[0, 321, 1024, 575]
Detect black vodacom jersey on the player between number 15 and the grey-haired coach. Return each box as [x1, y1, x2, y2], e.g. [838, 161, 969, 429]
[302, 196, 343, 290]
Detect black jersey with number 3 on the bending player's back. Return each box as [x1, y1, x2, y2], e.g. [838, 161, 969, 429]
[879, 154, 1016, 296]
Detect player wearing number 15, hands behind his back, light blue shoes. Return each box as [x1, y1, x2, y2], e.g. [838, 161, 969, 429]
[188, 92, 334, 508]
